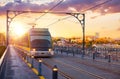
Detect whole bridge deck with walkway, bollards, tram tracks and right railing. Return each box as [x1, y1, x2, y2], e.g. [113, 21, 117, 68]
[0, 45, 120, 79]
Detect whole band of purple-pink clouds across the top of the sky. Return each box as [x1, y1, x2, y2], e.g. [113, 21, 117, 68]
[0, 0, 120, 15]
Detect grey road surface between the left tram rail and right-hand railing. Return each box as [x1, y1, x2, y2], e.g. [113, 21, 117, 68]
[40, 55, 120, 79]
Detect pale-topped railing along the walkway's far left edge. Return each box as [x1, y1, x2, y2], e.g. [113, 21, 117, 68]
[0, 47, 9, 79]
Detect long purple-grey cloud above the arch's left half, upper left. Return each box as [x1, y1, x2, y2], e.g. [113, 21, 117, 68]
[0, 2, 48, 15]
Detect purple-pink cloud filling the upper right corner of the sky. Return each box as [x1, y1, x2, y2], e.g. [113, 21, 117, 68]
[56, 0, 120, 13]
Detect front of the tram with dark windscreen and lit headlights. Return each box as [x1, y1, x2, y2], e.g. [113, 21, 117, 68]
[28, 28, 54, 57]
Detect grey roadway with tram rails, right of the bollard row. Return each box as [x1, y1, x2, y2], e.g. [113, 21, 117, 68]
[12, 46, 120, 79]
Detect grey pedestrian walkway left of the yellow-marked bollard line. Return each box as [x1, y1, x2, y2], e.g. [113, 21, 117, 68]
[5, 46, 39, 79]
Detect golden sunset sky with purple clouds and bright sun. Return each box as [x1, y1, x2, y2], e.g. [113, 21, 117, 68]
[0, 0, 120, 39]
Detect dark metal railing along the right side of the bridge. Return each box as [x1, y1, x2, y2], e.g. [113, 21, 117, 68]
[54, 46, 120, 62]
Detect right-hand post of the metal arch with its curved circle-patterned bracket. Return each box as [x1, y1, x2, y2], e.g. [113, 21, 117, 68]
[66, 13, 85, 58]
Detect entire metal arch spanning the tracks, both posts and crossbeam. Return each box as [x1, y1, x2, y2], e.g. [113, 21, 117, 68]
[6, 10, 85, 57]
